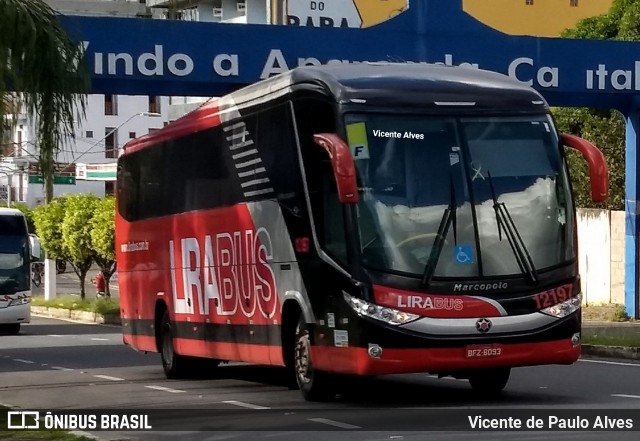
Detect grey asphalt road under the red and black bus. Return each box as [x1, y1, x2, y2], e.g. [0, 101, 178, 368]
[0, 318, 640, 441]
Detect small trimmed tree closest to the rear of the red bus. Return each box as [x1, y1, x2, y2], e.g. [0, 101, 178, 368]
[91, 197, 116, 297]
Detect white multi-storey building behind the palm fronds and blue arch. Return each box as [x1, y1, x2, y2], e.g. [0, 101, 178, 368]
[0, 0, 169, 206]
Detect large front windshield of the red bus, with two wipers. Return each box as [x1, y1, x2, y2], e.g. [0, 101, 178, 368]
[346, 114, 576, 280]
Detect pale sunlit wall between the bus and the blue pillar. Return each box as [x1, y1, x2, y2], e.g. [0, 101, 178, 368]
[577, 208, 624, 305]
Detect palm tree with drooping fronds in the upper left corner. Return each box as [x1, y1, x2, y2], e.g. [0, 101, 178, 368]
[0, 0, 89, 202]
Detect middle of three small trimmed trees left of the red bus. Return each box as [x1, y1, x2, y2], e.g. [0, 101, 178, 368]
[61, 194, 100, 299]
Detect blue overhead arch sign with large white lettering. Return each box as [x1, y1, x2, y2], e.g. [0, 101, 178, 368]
[63, 0, 640, 111]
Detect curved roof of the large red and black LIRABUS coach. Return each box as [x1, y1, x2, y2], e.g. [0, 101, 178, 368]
[125, 63, 548, 154]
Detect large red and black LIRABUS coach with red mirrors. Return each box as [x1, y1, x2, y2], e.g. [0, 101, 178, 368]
[116, 63, 608, 400]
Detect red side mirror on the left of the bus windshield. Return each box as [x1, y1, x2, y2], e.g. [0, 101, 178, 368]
[313, 133, 358, 204]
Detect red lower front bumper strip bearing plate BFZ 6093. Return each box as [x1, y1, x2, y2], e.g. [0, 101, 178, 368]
[311, 338, 580, 375]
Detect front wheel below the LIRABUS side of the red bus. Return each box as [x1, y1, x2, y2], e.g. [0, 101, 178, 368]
[293, 316, 335, 401]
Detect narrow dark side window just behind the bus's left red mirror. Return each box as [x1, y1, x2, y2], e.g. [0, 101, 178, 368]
[294, 98, 347, 265]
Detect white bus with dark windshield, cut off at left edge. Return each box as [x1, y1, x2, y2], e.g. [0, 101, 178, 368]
[0, 208, 40, 334]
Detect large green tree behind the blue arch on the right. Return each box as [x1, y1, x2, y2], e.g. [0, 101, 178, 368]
[554, 0, 640, 210]
